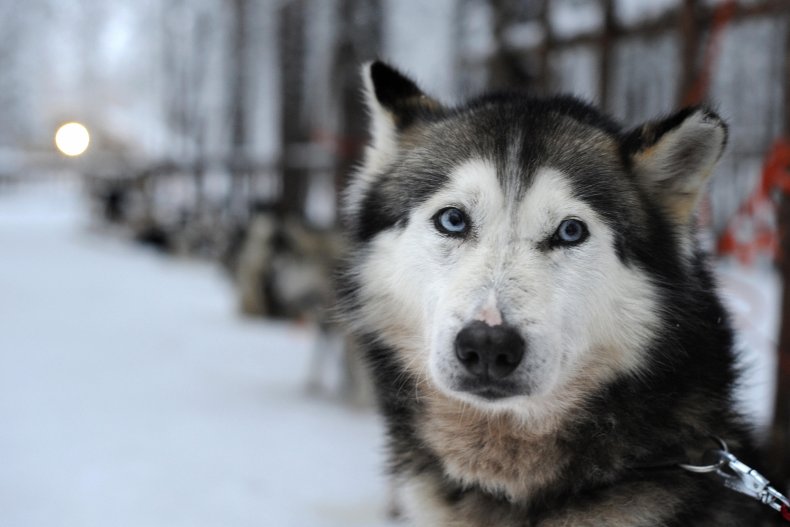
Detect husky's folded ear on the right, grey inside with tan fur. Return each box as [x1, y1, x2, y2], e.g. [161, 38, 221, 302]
[623, 107, 727, 225]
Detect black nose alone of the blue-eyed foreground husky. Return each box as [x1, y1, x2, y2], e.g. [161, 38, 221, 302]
[455, 320, 525, 379]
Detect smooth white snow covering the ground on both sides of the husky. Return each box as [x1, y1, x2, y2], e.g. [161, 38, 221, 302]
[0, 179, 778, 527]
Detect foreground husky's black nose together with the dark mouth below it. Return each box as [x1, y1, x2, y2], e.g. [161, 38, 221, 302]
[455, 320, 526, 399]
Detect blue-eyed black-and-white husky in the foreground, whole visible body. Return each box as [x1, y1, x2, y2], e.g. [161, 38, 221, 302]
[342, 62, 772, 527]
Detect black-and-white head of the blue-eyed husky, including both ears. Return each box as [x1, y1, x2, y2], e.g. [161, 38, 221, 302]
[346, 63, 726, 412]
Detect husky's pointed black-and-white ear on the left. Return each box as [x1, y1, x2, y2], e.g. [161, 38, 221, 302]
[362, 61, 442, 166]
